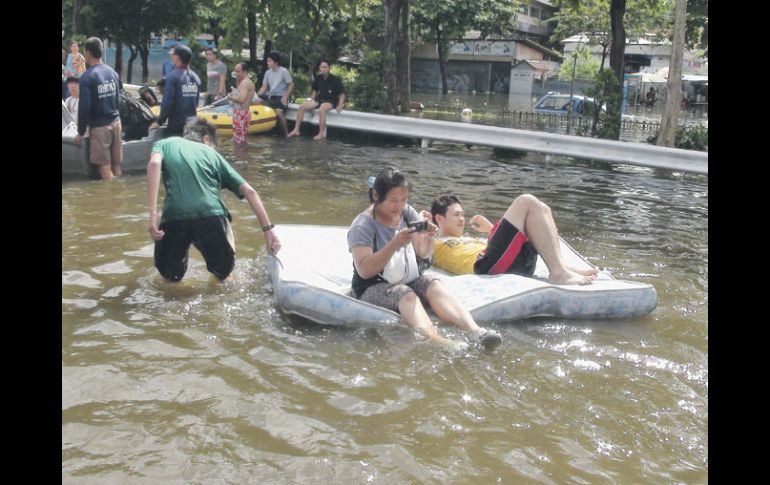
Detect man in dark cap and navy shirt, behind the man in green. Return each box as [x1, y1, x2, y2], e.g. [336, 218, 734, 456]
[150, 44, 201, 138]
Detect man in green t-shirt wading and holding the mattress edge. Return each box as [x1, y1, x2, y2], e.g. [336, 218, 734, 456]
[147, 118, 281, 282]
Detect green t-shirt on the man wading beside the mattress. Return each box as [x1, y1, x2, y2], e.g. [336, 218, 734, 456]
[152, 136, 245, 223]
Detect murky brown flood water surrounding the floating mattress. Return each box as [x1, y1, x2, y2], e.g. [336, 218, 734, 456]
[62, 136, 708, 484]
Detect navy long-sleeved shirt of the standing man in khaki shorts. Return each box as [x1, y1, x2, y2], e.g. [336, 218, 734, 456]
[78, 64, 120, 136]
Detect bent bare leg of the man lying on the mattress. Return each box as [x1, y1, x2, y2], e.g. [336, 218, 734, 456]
[503, 194, 596, 285]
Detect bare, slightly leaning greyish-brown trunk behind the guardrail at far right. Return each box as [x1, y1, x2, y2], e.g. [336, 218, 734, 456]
[657, 0, 687, 148]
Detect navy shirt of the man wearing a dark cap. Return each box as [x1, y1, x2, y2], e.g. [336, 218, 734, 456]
[158, 68, 201, 129]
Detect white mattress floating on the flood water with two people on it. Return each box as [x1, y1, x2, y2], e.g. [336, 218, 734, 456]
[267, 225, 657, 327]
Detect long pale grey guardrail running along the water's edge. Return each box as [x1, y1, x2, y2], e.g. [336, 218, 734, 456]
[286, 103, 708, 175]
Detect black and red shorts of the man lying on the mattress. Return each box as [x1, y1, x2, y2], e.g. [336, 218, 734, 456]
[473, 219, 537, 277]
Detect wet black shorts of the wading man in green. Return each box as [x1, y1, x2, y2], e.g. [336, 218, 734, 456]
[155, 216, 235, 281]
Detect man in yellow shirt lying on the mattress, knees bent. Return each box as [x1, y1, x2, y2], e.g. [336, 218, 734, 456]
[422, 194, 598, 285]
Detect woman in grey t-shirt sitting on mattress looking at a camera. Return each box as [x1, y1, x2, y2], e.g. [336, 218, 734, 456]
[348, 168, 502, 347]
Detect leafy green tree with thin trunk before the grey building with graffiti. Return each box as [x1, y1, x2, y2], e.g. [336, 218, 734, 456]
[414, 0, 518, 94]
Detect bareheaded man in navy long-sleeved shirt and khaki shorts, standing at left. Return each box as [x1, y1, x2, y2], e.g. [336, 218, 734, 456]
[75, 37, 123, 180]
